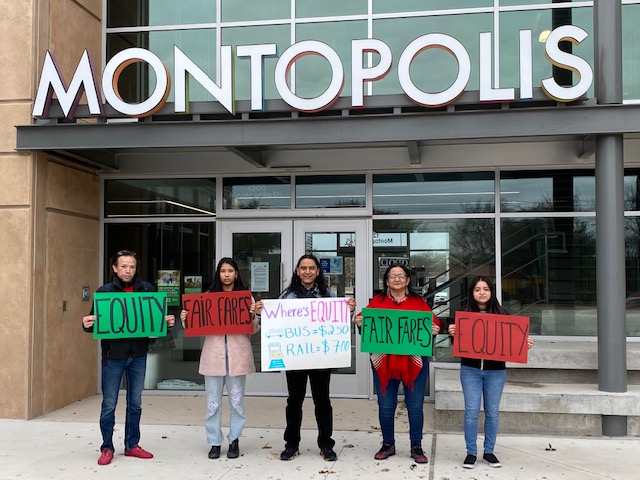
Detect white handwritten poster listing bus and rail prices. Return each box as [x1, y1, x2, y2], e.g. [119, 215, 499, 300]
[260, 298, 351, 372]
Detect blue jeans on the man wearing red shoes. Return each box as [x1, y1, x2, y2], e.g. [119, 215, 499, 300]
[100, 355, 147, 451]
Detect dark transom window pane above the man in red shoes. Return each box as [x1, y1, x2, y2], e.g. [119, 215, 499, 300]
[104, 178, 216, 218]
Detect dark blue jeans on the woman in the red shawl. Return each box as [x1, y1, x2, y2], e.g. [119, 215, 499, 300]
[372, 357, 429, 447]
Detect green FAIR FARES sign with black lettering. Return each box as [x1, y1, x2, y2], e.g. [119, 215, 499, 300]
[360, 308, 433, 357]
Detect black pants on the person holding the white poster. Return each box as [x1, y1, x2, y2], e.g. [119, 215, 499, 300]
[284, 370, 336, 449]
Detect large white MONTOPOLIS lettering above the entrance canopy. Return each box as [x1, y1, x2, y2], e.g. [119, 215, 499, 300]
[33, 25, 593, 118]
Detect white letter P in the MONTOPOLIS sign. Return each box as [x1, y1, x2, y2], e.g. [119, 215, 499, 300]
[351, 38, 393, 107]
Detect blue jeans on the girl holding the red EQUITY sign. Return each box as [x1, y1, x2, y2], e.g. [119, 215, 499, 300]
[460, 365, 507, 455]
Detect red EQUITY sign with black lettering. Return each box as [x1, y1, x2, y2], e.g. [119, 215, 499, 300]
[453, 312, 529, 363]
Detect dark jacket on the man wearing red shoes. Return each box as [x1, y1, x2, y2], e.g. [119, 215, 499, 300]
[82, 275, 156, 365]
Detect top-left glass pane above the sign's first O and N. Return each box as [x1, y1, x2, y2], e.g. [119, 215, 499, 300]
[107, 0, 216, 28]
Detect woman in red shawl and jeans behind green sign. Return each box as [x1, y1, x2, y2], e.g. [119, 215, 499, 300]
[355, 264, 440, 463]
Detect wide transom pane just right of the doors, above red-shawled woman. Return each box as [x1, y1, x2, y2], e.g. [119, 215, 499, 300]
[373, 172, 495, 215]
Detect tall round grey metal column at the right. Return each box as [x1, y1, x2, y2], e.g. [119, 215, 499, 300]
[594, 0, 627, 436]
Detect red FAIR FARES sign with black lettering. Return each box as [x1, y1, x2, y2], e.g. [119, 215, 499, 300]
[182, 290, 253, 337]
